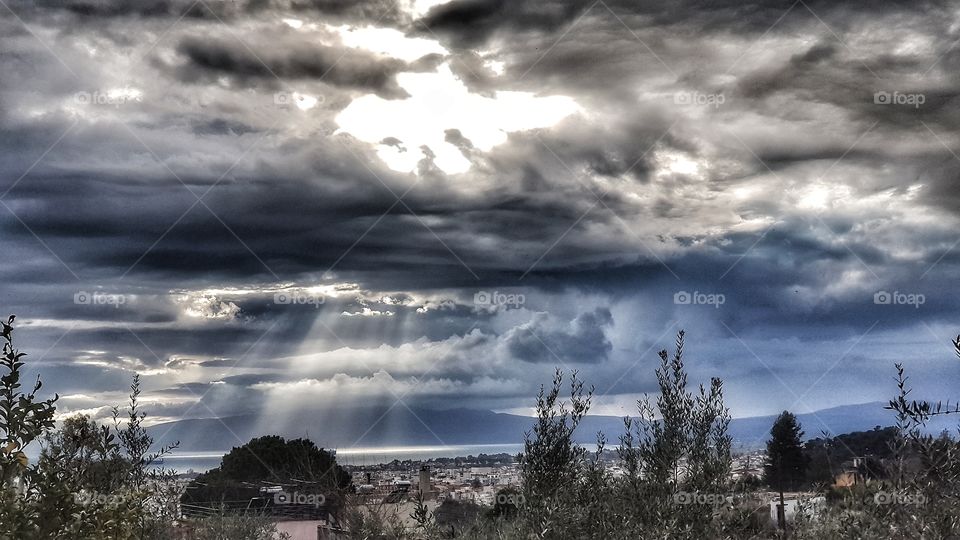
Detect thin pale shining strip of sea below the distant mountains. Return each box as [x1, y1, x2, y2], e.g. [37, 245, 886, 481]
[156, 444, 523, 473]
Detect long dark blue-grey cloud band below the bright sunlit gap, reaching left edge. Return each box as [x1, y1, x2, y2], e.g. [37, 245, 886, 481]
[0, 116, 660, 287]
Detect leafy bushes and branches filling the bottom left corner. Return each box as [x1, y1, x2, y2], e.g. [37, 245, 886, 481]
[0, 316, 288, 540]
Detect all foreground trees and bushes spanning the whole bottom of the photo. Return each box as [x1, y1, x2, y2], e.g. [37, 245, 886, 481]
[0, 317, 960, 540]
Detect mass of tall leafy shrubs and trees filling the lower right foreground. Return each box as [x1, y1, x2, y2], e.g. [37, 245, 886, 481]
[349, 333, 960, 540]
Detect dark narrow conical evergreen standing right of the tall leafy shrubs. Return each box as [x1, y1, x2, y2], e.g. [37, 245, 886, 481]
[763, 411, 808, 492]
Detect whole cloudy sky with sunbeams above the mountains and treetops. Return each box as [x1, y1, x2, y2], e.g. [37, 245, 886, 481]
[0, 0, 960, 440]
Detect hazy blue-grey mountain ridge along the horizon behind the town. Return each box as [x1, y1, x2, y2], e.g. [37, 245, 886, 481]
[149, 402, 956, 452]
